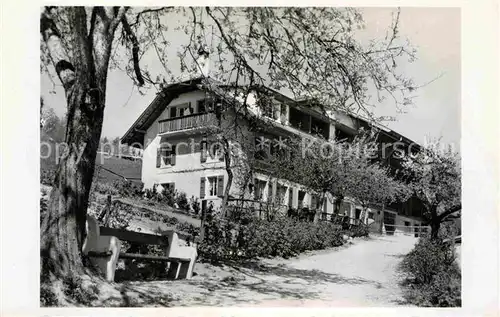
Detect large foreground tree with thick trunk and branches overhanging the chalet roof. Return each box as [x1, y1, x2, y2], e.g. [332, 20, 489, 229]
[40, 7, 415, 277]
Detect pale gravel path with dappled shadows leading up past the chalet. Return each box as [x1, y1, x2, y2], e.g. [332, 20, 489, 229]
[96, 236, 416, 307]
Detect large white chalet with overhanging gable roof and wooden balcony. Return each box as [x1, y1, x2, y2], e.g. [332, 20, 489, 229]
[122, 77, 422, 235]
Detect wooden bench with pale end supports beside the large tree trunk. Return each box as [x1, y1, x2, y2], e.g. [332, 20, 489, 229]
[83, 216, 197, 281]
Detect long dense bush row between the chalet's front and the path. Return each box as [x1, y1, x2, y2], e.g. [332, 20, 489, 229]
[199, 207, 344, 262]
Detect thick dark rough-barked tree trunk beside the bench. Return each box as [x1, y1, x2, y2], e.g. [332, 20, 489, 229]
[40, 7, 124, 277]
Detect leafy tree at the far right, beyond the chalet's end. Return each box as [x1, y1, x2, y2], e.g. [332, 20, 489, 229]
[404, 143, 462, 239]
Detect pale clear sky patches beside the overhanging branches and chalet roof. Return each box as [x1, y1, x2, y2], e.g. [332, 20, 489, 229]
[41, 7, 461, 151]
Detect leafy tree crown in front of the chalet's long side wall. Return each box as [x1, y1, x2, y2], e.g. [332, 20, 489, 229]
[270, 132, 408, 221]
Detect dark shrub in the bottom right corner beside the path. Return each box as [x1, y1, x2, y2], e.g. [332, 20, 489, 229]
[400, 238, 461, 307]
